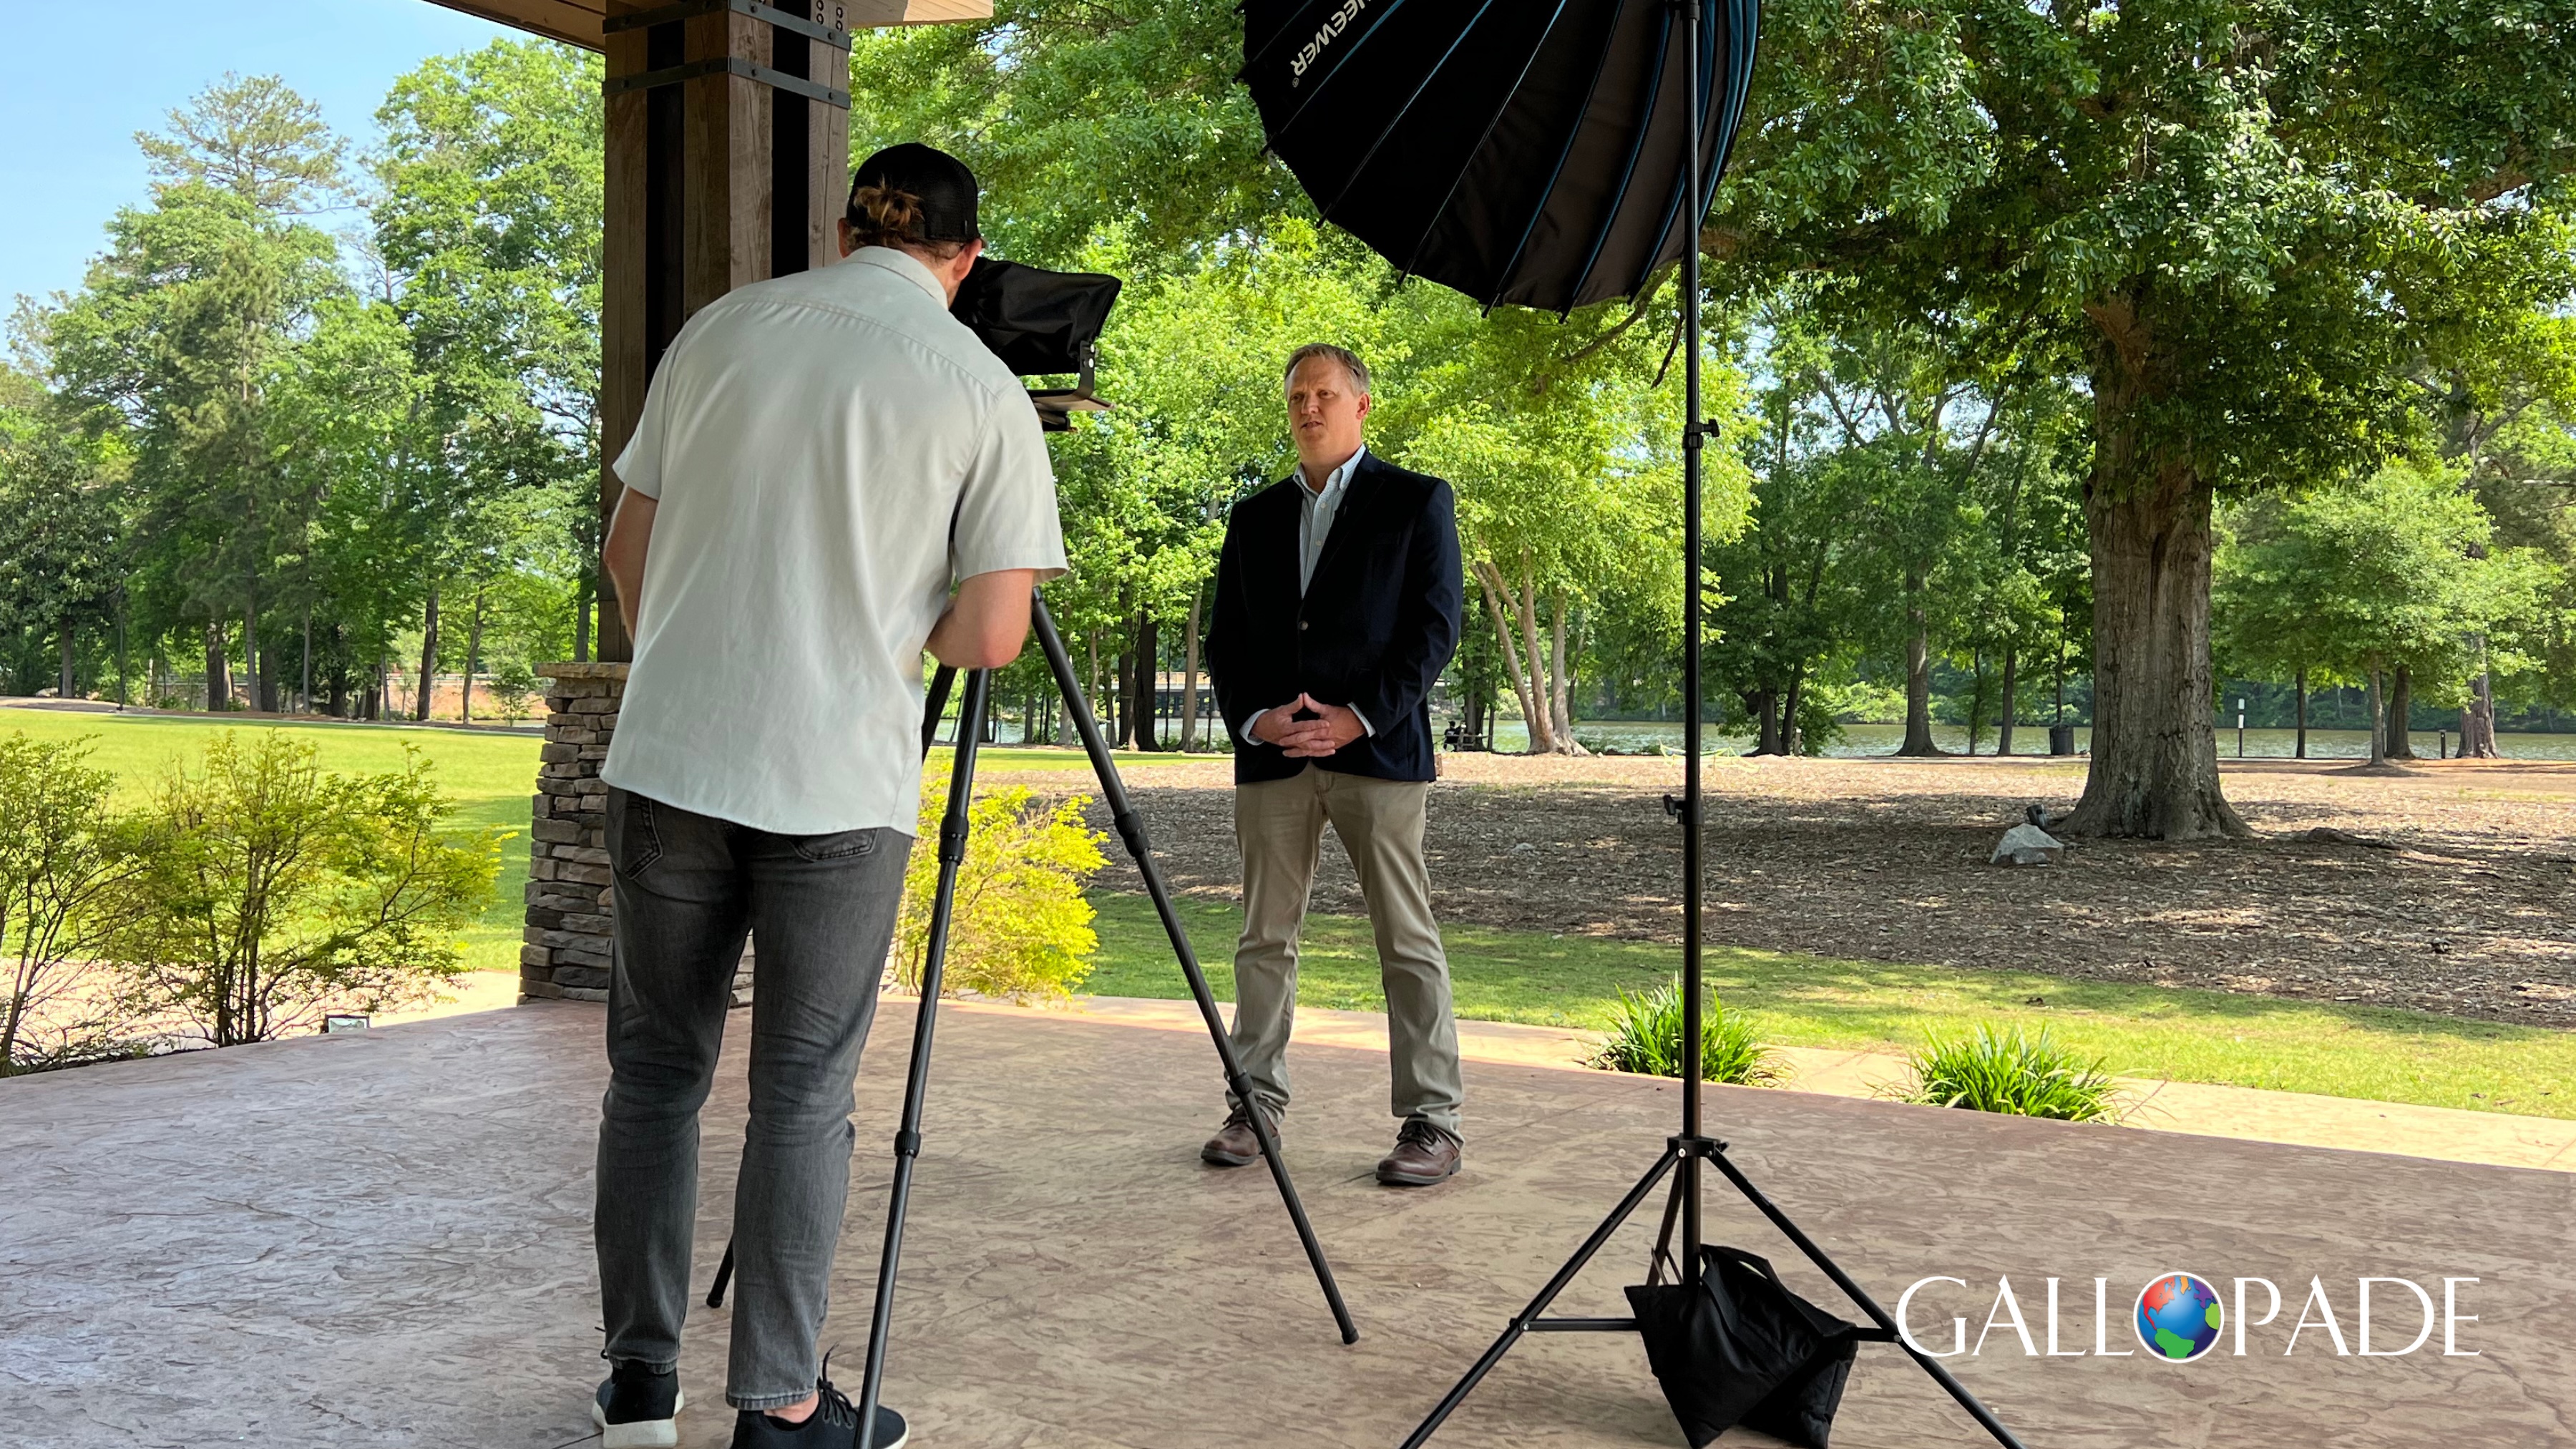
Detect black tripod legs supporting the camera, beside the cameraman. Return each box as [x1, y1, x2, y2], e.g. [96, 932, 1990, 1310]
[706, 595, 1360, 1449]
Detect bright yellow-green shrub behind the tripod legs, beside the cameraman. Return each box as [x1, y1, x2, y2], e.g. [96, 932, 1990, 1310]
[894, 771, 1108, 1000]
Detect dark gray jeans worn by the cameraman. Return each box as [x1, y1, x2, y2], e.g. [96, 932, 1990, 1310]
[592, 789, 912, 1407]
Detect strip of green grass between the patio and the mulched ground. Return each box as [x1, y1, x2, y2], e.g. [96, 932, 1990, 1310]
[1082, 892, 2576, 1116]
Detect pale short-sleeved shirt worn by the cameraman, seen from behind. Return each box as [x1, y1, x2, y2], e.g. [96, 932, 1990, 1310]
[600, 248, 1064, 835]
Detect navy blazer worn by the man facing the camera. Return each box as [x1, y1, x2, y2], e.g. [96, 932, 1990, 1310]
[1208, 452, 1465, 784]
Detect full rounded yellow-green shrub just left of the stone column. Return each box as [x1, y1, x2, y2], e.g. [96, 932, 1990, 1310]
[108, 730, 502, 1047]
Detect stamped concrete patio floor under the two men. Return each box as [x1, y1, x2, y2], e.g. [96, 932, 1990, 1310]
[0, 1003, 2576, 1449]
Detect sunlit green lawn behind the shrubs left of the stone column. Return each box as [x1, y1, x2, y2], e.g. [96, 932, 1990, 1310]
[0, 709, 538, 972]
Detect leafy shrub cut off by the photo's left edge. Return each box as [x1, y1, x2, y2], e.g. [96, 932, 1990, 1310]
[0, 732, 139, 1075]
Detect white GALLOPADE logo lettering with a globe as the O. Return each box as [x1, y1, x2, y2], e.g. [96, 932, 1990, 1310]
[1896, 1274, 2478, 1364]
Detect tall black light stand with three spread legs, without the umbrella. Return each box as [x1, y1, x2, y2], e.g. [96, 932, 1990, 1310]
[1404, 0, 2025, 1449]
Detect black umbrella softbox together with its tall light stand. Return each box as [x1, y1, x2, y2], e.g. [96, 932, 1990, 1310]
[1241, 0, 2019, 1449]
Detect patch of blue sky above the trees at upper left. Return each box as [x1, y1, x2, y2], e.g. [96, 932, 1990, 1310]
[0, 0, 528, 307]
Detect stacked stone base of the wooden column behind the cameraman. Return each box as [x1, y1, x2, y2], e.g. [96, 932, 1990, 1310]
[518, 665, 752, 1005]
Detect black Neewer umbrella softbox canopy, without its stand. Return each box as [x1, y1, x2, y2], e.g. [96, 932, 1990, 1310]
[1244, 0, 1760, 312]
